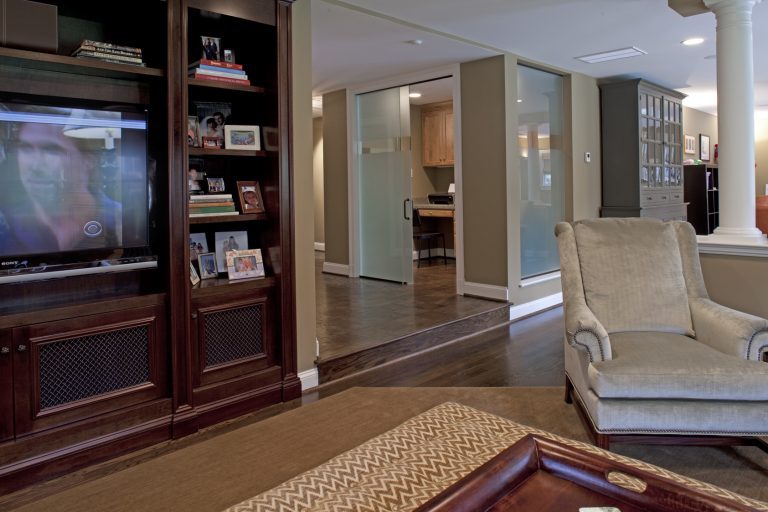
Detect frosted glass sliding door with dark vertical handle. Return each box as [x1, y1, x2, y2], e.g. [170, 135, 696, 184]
[357, 87, 413, 283]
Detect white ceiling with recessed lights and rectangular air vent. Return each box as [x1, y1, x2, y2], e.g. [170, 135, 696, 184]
[312, 0, 768, 113]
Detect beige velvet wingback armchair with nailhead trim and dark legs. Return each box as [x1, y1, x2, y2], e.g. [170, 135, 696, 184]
[555, 218, 768, 450]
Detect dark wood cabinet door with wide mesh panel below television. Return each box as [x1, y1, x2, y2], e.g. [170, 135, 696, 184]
[13, 306, 167, 438]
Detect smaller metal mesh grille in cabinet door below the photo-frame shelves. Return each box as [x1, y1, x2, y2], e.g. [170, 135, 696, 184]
[203, 304, 264, 367]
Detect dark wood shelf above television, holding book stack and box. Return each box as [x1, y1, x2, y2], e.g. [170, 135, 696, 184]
[0, 47, 165, 78]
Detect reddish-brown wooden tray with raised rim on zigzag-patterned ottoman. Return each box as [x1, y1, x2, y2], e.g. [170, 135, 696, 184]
[418, 434, 755, 512]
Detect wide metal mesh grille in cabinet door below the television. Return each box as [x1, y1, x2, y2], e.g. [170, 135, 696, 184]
[40, 326, 150, 410]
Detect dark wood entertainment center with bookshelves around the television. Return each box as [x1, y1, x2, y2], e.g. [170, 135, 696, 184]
[0, 0, 301, 494]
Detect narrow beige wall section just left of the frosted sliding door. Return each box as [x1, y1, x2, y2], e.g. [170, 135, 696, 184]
[322, 89, 349, 265]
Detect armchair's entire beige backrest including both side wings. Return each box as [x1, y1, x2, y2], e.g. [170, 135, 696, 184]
[555, 218, 706, 336]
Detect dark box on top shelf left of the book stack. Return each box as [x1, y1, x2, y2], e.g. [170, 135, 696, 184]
[0, 0, 59, 53]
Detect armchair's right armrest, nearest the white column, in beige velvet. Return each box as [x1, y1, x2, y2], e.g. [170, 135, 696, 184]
[689, 297, 768, 361]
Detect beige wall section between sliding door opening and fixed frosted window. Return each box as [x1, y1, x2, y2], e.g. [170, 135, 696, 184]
[460, 56, 508, 287]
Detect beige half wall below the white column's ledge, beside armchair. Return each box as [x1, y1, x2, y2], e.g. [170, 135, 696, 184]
[700, 254, 768, 318]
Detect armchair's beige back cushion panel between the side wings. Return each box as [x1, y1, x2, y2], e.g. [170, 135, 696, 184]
[574, 219, 693, 335]
